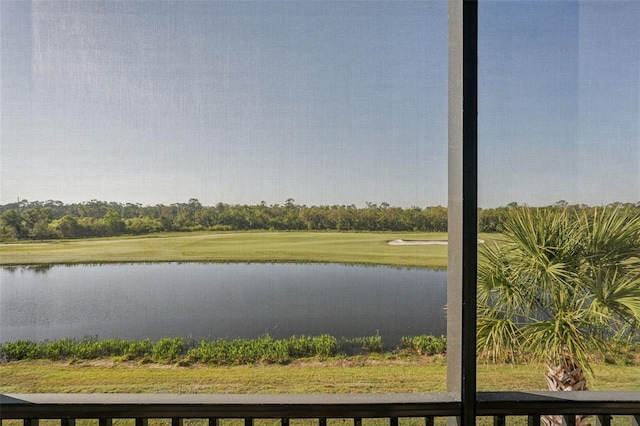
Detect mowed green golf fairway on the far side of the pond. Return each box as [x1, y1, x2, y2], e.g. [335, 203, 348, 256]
[0, 232, 484, 268]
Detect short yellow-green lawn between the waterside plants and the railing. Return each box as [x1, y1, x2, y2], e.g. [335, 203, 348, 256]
[0, 357, 640, 394]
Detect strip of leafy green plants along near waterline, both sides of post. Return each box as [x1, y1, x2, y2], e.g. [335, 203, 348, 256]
[0, 334, 640, 367]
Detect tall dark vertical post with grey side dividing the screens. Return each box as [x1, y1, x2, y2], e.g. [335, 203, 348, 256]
[447, 0, 478, 425]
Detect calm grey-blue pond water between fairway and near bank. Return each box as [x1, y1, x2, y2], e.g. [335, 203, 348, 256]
[0, 263, 446, 344]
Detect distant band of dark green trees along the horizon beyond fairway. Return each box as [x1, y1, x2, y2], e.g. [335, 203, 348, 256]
[0, 198, 640, 241]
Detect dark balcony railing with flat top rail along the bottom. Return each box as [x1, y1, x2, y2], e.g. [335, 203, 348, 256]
[0, 392, 640, 426]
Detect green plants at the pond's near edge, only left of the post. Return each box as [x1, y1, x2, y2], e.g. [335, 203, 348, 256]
[0, 334, 446, 365]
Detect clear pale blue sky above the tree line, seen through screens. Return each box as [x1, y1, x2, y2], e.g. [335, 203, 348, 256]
[0, 0, 640, 207]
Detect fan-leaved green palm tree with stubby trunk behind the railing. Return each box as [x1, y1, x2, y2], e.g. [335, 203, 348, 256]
[477, 208, 640, 424]
